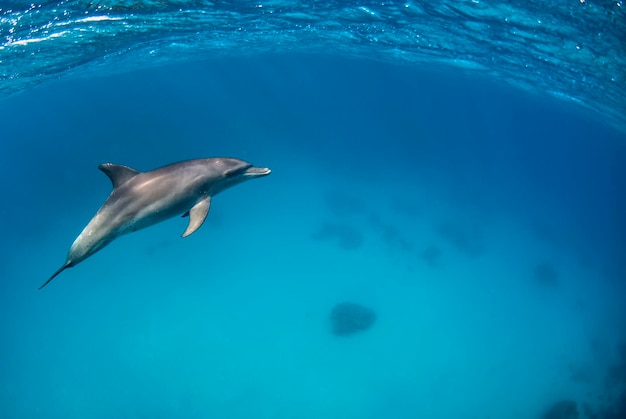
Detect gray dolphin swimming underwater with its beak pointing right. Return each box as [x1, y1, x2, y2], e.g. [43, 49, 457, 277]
[39, 157, 271, 289]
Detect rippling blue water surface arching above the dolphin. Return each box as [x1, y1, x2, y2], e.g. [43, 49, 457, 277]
[0, 0, 626, 131]
